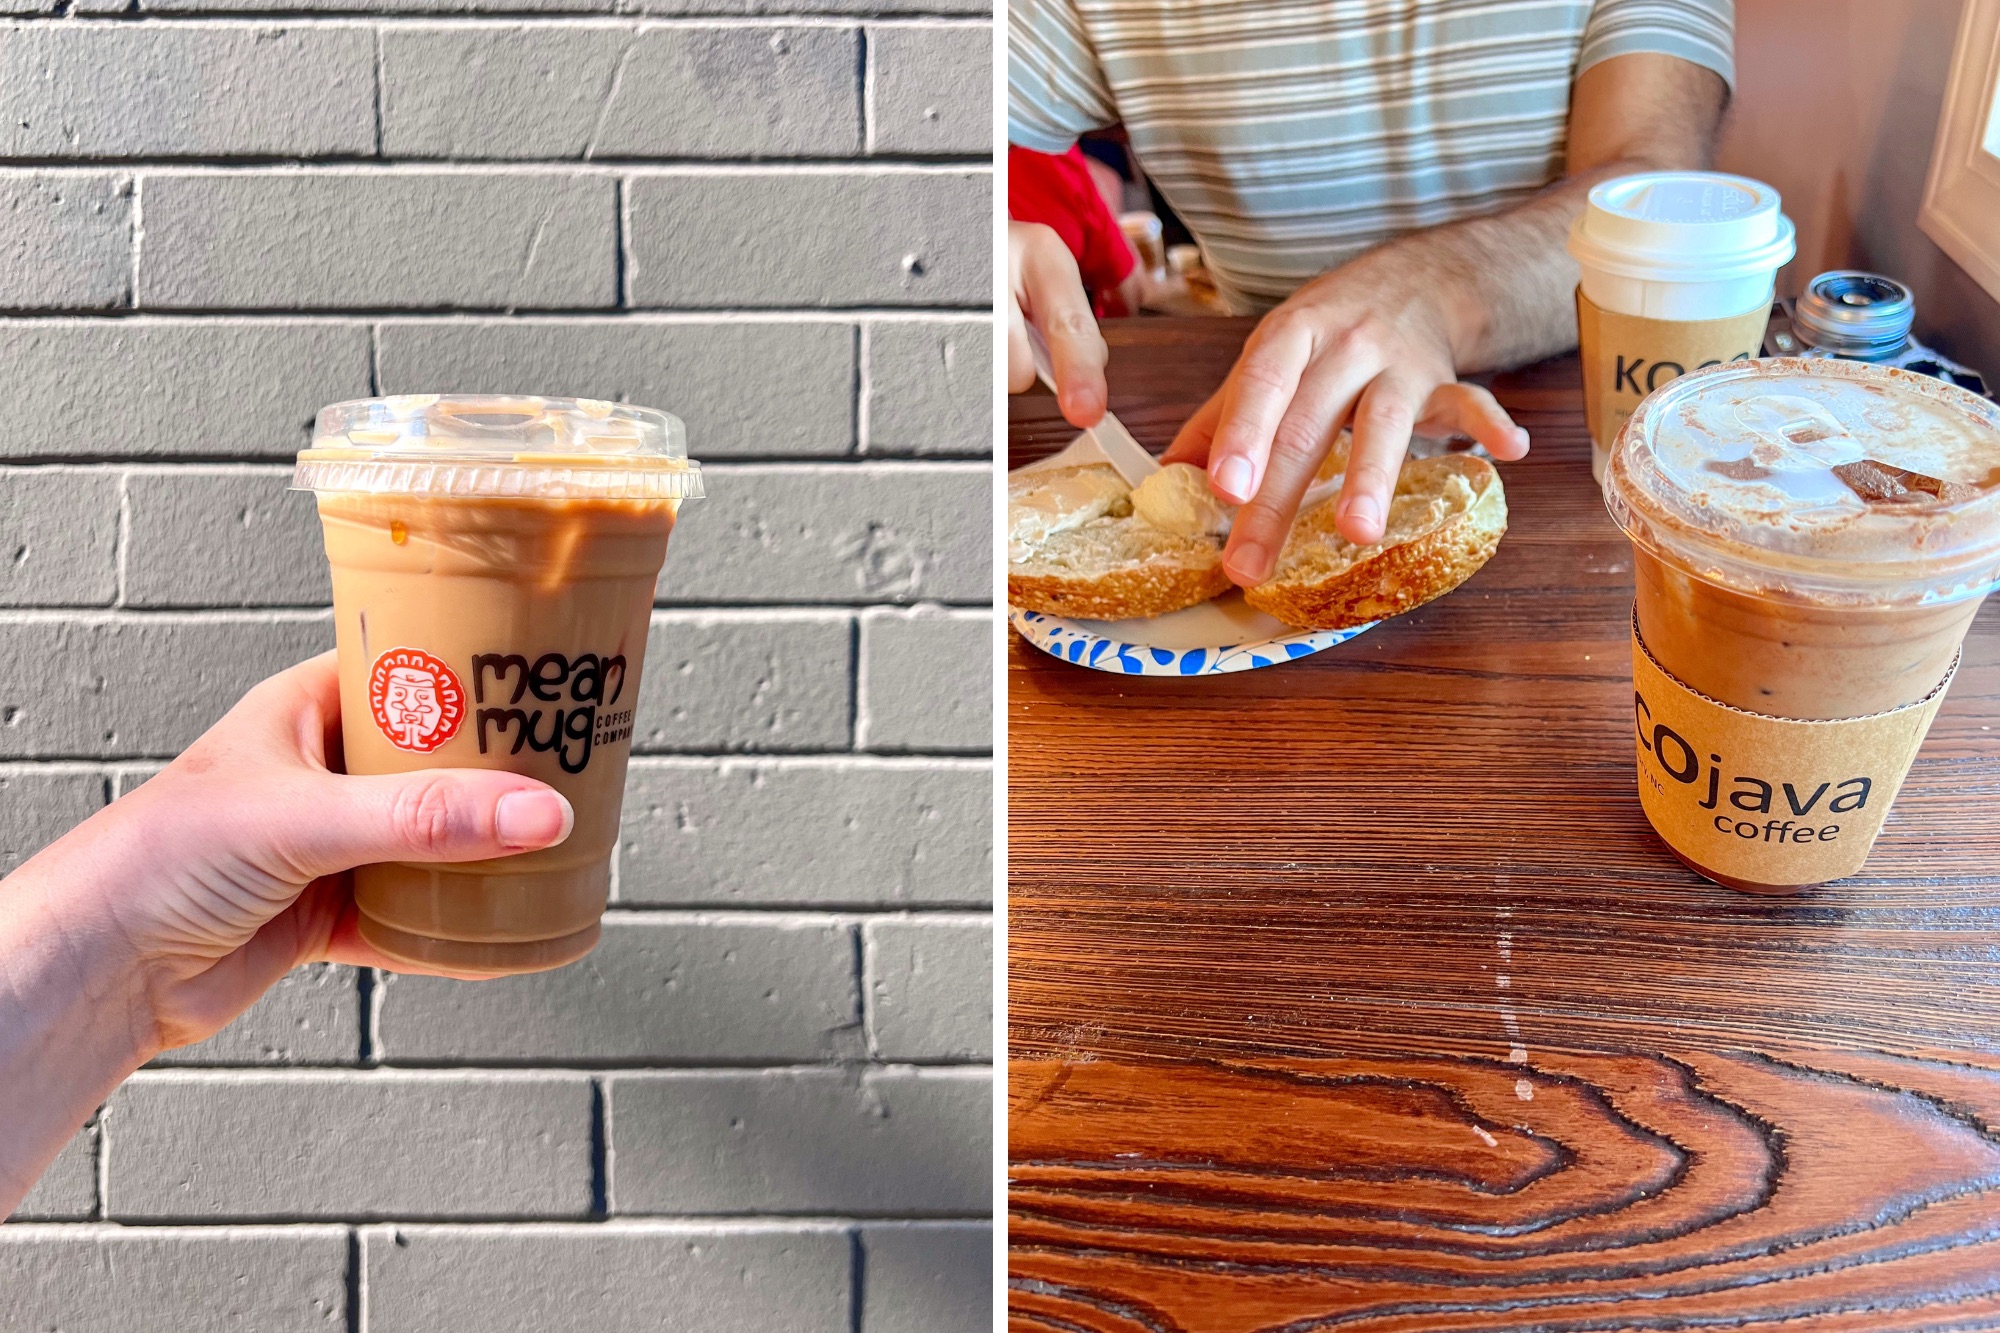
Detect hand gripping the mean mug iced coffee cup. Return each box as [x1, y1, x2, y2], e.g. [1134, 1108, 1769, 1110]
[0, 652, 572, 1063]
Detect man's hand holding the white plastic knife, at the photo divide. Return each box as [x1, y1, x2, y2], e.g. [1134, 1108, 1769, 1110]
[1006, 222, 1110, 430]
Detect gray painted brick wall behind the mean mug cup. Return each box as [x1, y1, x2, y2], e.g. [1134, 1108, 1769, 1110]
[0, 0, 992, 1333]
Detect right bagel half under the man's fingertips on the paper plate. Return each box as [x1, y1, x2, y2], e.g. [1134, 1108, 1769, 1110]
[1244, 454, 1506, 628]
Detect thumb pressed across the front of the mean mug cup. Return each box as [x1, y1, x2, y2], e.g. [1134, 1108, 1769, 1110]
[272, 769, 576, 879]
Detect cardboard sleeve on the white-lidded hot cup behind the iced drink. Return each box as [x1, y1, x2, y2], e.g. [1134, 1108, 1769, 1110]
[1576, 288, 1770, 448]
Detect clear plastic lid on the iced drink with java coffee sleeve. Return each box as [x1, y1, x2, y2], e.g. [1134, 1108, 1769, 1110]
[1604, 358, 2000, 604]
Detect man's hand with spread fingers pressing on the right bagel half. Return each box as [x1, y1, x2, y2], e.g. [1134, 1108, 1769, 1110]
[1160, 236, 1528, 586]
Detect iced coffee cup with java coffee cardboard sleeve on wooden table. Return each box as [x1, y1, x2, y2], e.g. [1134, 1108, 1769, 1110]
[1604, 360, 2000, 893]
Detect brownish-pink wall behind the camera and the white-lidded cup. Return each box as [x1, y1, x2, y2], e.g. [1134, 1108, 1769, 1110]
[1718, 0, 2000, 368]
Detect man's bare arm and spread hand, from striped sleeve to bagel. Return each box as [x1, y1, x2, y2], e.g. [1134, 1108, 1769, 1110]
[1164, 54, 1728, 586]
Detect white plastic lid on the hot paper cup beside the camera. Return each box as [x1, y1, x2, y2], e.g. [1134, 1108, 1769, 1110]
[1570, 172, 1798, 282]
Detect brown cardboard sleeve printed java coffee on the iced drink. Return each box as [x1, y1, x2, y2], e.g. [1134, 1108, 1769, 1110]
[1632, 622, 1958, 891]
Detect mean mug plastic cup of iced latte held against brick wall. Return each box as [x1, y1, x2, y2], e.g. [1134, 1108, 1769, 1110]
[294, 396, 702, 975]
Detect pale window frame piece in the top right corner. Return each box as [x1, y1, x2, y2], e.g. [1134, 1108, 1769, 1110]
[1916, 0, 2000, 300]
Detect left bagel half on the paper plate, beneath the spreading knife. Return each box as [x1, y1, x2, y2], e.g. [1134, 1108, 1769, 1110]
[1006, 464, 1230, 620]
